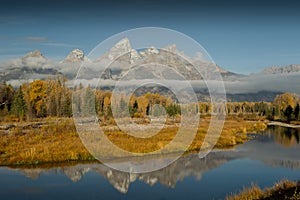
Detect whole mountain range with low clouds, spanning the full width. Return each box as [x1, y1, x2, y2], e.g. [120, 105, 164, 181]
[0, 38, 300, 101]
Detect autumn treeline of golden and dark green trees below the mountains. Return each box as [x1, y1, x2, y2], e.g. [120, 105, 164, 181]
[0, 77, 300, 121]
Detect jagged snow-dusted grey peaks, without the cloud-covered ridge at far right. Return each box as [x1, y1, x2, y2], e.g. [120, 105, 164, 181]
[0, 38, 240, 81]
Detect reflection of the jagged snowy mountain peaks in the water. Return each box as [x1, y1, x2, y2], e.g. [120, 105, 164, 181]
[14, 151, 236, 193]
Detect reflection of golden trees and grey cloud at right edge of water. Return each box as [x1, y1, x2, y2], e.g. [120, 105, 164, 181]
[237, 126, 300, 169]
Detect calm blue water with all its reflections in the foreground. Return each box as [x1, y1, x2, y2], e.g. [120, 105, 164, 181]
[0, 126, 300, 200]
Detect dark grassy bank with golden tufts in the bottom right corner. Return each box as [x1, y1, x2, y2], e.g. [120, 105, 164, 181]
[226, 180, 300, 200]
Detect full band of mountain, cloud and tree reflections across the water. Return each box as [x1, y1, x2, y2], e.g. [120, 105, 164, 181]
[1, 126, 300, 194]
